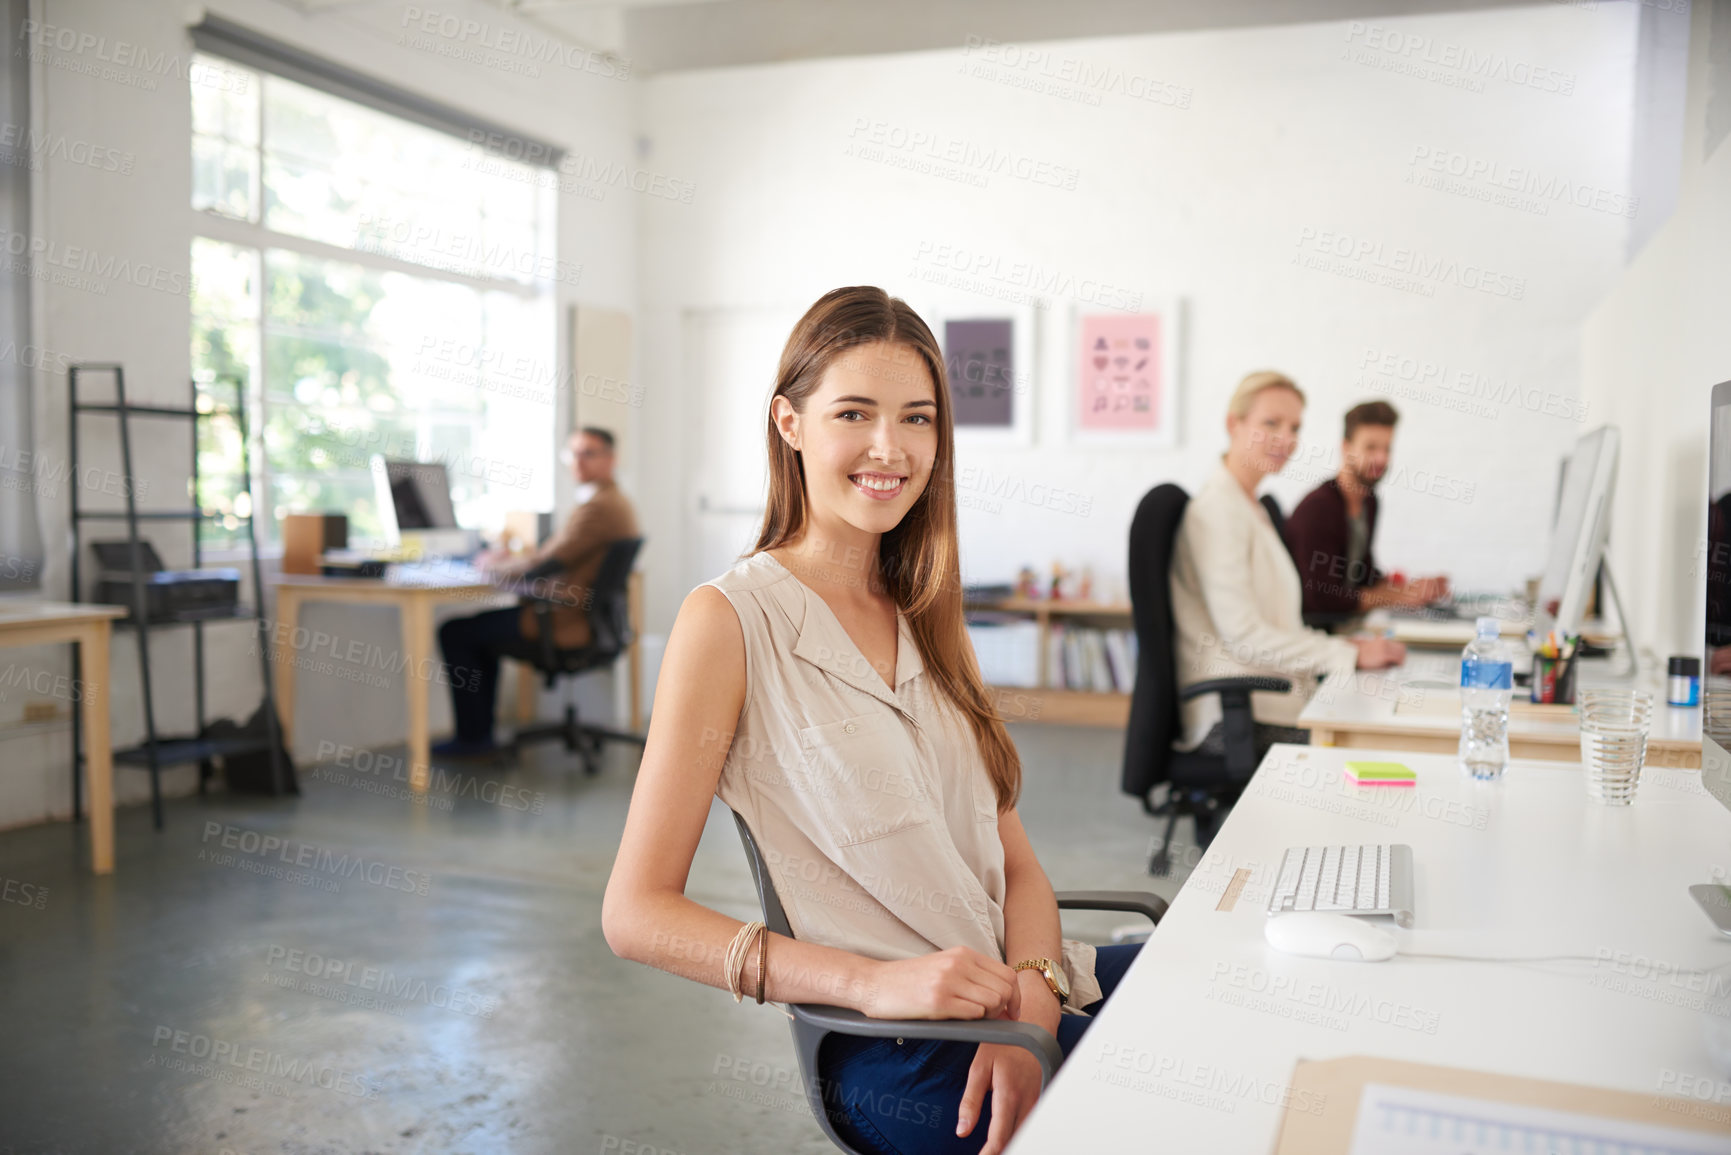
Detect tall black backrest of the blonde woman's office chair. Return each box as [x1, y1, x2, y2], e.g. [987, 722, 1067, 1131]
[1122, 485, 1189, 798]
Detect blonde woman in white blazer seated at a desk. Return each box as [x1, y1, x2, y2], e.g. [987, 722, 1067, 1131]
[1172, 371, 1406, 753]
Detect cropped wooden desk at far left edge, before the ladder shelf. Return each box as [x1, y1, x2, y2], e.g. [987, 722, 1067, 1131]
[0, 601, 126, 874]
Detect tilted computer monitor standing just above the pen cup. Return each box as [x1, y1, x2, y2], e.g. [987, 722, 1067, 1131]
[1534, 426, 1627, 634]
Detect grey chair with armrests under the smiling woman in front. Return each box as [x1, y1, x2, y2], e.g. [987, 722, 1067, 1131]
[734, 810, 1167, 1155]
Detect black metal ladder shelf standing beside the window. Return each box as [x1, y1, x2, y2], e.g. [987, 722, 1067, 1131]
[68, 364, 284, 829]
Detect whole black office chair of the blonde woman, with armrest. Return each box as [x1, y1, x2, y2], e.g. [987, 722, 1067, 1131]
[1122, 485, 1291, 876]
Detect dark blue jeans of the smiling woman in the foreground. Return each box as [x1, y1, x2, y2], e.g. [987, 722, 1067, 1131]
[817, 942, 1142, 1155]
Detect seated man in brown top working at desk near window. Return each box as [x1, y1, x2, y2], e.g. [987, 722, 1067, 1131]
[433, 428, 637, 757]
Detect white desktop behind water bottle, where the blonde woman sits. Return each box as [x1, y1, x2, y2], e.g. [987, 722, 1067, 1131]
[1298, 651, 1702, 750]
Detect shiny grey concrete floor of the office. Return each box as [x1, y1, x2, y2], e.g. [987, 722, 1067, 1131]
[0, 726, 1194, 1155]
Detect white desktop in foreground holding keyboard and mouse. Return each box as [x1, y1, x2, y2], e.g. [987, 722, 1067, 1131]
[1011, 746, 1731, 1155]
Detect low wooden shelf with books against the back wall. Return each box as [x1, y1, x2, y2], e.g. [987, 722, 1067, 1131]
[968, 597, 1136, 727]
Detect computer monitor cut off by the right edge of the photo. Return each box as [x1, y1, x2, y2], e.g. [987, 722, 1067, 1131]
[1702, 381, 1731, 807]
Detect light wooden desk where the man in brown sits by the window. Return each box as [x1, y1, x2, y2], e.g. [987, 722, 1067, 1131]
[272, 573, 642, 790]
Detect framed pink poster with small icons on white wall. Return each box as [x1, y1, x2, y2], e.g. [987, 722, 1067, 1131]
[1071, 305, 1177, 445]
